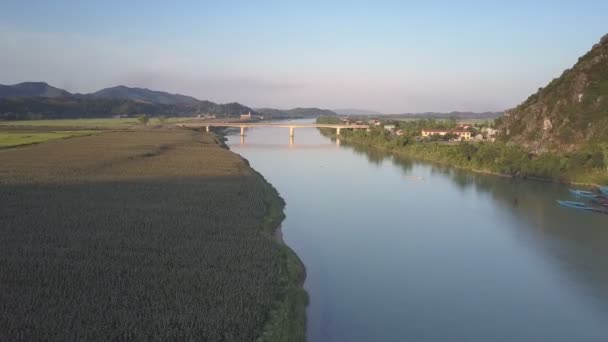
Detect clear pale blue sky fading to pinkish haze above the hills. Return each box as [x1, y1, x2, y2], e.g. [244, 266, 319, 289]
[0, 0, 608, 113]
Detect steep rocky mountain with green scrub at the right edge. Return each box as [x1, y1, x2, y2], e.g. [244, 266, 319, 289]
[497, 35, 608, 153]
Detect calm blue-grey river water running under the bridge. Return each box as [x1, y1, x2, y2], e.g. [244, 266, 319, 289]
[228, 120, 608, 342]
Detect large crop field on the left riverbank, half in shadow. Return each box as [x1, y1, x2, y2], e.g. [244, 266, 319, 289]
[0, 130, 306, 341]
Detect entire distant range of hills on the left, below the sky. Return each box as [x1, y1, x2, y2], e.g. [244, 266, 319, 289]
[0, 82, 336, 120]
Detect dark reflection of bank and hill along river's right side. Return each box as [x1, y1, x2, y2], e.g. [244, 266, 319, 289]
[342, 142, 608, 312]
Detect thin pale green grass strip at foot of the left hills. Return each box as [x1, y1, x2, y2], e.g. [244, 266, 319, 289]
[0, 118, 192, 128]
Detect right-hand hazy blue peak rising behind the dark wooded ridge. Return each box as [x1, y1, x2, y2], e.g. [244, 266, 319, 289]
[91, 85, 200, 105]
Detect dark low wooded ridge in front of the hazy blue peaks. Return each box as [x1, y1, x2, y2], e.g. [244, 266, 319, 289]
[0, 96, 255, 120]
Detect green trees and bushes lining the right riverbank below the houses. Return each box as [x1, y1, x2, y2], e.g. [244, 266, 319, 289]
[319, 118, 608, 183]
